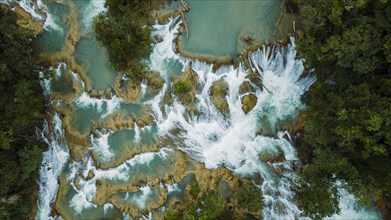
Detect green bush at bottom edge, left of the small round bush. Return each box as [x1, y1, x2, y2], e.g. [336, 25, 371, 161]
[184, 193, 224, 220]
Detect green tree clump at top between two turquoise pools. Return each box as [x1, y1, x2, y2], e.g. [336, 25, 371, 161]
[94, 0, 152, 79]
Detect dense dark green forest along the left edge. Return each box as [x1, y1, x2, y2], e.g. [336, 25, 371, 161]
[0, 6, 46, 219]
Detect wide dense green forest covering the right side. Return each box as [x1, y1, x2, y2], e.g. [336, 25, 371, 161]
[287, 0, 391, 219]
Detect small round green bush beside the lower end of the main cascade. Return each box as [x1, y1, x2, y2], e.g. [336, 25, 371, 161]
[235, 184, 263, 212]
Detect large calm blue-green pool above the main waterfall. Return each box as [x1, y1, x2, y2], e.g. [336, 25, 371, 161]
[182, 0, 281, 56]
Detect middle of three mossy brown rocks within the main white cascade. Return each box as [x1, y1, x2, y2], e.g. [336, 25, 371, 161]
[210, 80, 229, 115]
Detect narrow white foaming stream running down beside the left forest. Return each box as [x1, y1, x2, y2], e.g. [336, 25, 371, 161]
[35, 113, 69, 219]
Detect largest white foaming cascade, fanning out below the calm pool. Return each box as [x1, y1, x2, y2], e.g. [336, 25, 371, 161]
[150, 36, 315, 219]
